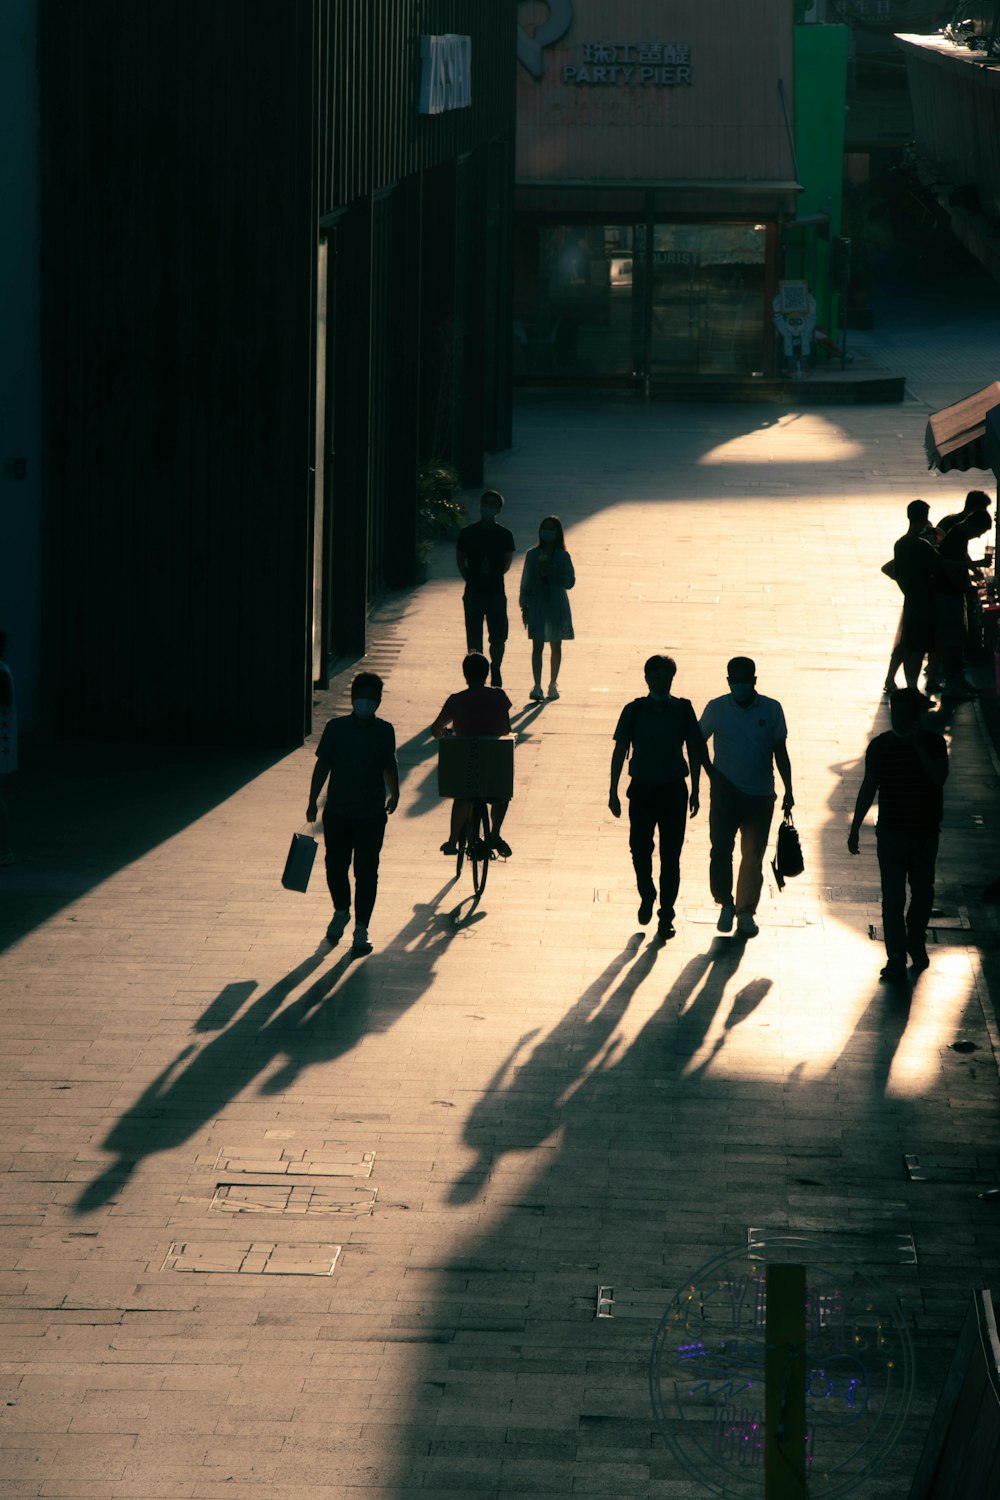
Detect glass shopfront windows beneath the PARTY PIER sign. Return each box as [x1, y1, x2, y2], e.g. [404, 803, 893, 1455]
[513, 221, 766, 378]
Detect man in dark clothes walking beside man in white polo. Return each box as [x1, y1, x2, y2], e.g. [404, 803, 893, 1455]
[607, 656, 711, 939]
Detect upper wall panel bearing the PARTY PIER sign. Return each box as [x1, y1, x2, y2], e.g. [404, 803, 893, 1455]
[517, 0, 793, 182]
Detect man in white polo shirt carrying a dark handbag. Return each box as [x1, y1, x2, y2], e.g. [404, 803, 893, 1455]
[700, 657, 795, 938]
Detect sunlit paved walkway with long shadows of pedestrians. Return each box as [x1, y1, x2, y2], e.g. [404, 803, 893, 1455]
[0, 276, 1000, 1500]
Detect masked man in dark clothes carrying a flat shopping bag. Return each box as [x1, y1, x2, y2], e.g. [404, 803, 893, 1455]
[306, 672, 399, 956]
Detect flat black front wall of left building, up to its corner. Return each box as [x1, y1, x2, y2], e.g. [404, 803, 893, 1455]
[39, 0, 313, 743]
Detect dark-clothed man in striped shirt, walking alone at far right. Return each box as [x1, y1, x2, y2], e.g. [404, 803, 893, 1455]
[847, 687, 948, 984]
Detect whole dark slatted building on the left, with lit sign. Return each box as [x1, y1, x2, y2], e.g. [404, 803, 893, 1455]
[37, 0, 514, 746]
